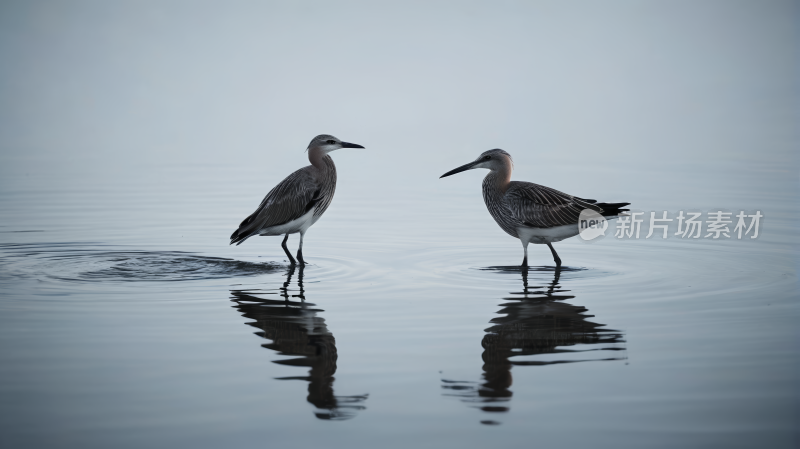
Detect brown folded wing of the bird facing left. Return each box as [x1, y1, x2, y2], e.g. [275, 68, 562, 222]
[505, 181, 602, 228]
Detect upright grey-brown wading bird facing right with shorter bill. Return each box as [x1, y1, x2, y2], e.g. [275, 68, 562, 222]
[230, 134, 364, 265]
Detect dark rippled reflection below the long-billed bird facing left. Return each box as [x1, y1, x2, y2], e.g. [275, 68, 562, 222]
[442, 267, 626, 424]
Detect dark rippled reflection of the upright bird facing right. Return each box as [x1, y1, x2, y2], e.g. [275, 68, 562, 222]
[231, 265, 367, 420]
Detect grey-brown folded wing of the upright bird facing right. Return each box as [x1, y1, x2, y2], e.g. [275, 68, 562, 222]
[231, 166, 320, 243]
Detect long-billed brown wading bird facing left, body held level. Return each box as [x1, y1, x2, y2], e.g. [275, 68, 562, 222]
[439, 148, 630, 267]
